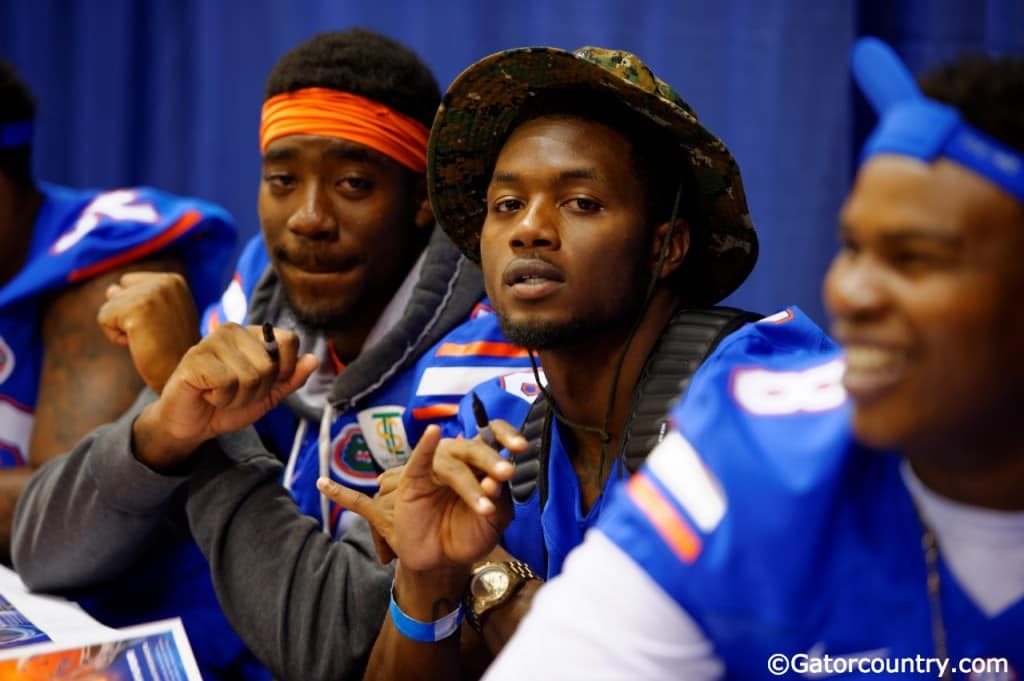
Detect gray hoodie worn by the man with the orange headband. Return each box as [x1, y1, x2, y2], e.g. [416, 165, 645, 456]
[12, 230, 482, 681]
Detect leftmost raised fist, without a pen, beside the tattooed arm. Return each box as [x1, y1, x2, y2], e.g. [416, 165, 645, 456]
[96, 272, 200, 394]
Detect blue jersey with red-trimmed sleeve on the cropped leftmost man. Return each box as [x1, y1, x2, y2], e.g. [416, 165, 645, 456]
[0, 183, 236, 467]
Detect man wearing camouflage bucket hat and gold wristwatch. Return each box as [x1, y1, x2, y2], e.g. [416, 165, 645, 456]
[323, 47, 811, 679]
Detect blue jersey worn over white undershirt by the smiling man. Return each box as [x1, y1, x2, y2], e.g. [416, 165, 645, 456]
[598, 309, 1024, 679]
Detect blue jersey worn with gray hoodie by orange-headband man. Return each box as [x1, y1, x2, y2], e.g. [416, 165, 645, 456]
[202, 235, 529, 536]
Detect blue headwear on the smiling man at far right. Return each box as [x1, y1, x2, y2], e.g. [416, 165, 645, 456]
[851, 38, 1024, 203]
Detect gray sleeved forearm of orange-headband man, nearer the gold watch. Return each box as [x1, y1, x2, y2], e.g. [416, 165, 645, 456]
[186, 444, 393, 681]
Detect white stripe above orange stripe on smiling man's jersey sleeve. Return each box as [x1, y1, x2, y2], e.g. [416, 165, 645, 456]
[646, 430, 728, 534]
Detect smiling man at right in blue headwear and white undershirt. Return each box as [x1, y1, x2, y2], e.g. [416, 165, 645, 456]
[479, 39, 1024, 680]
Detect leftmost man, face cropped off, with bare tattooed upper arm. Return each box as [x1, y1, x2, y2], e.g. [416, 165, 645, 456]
[0, 59, 236, 563]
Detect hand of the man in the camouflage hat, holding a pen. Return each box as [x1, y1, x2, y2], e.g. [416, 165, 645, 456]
[321, 421, 526, 572]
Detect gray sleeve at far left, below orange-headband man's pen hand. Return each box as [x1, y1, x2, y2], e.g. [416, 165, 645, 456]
[11, 390, 185, 591]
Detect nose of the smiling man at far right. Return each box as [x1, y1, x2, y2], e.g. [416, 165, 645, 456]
[822, 252, 889, 320]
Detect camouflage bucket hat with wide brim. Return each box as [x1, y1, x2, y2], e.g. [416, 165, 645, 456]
[427, 47, 758, 305]
